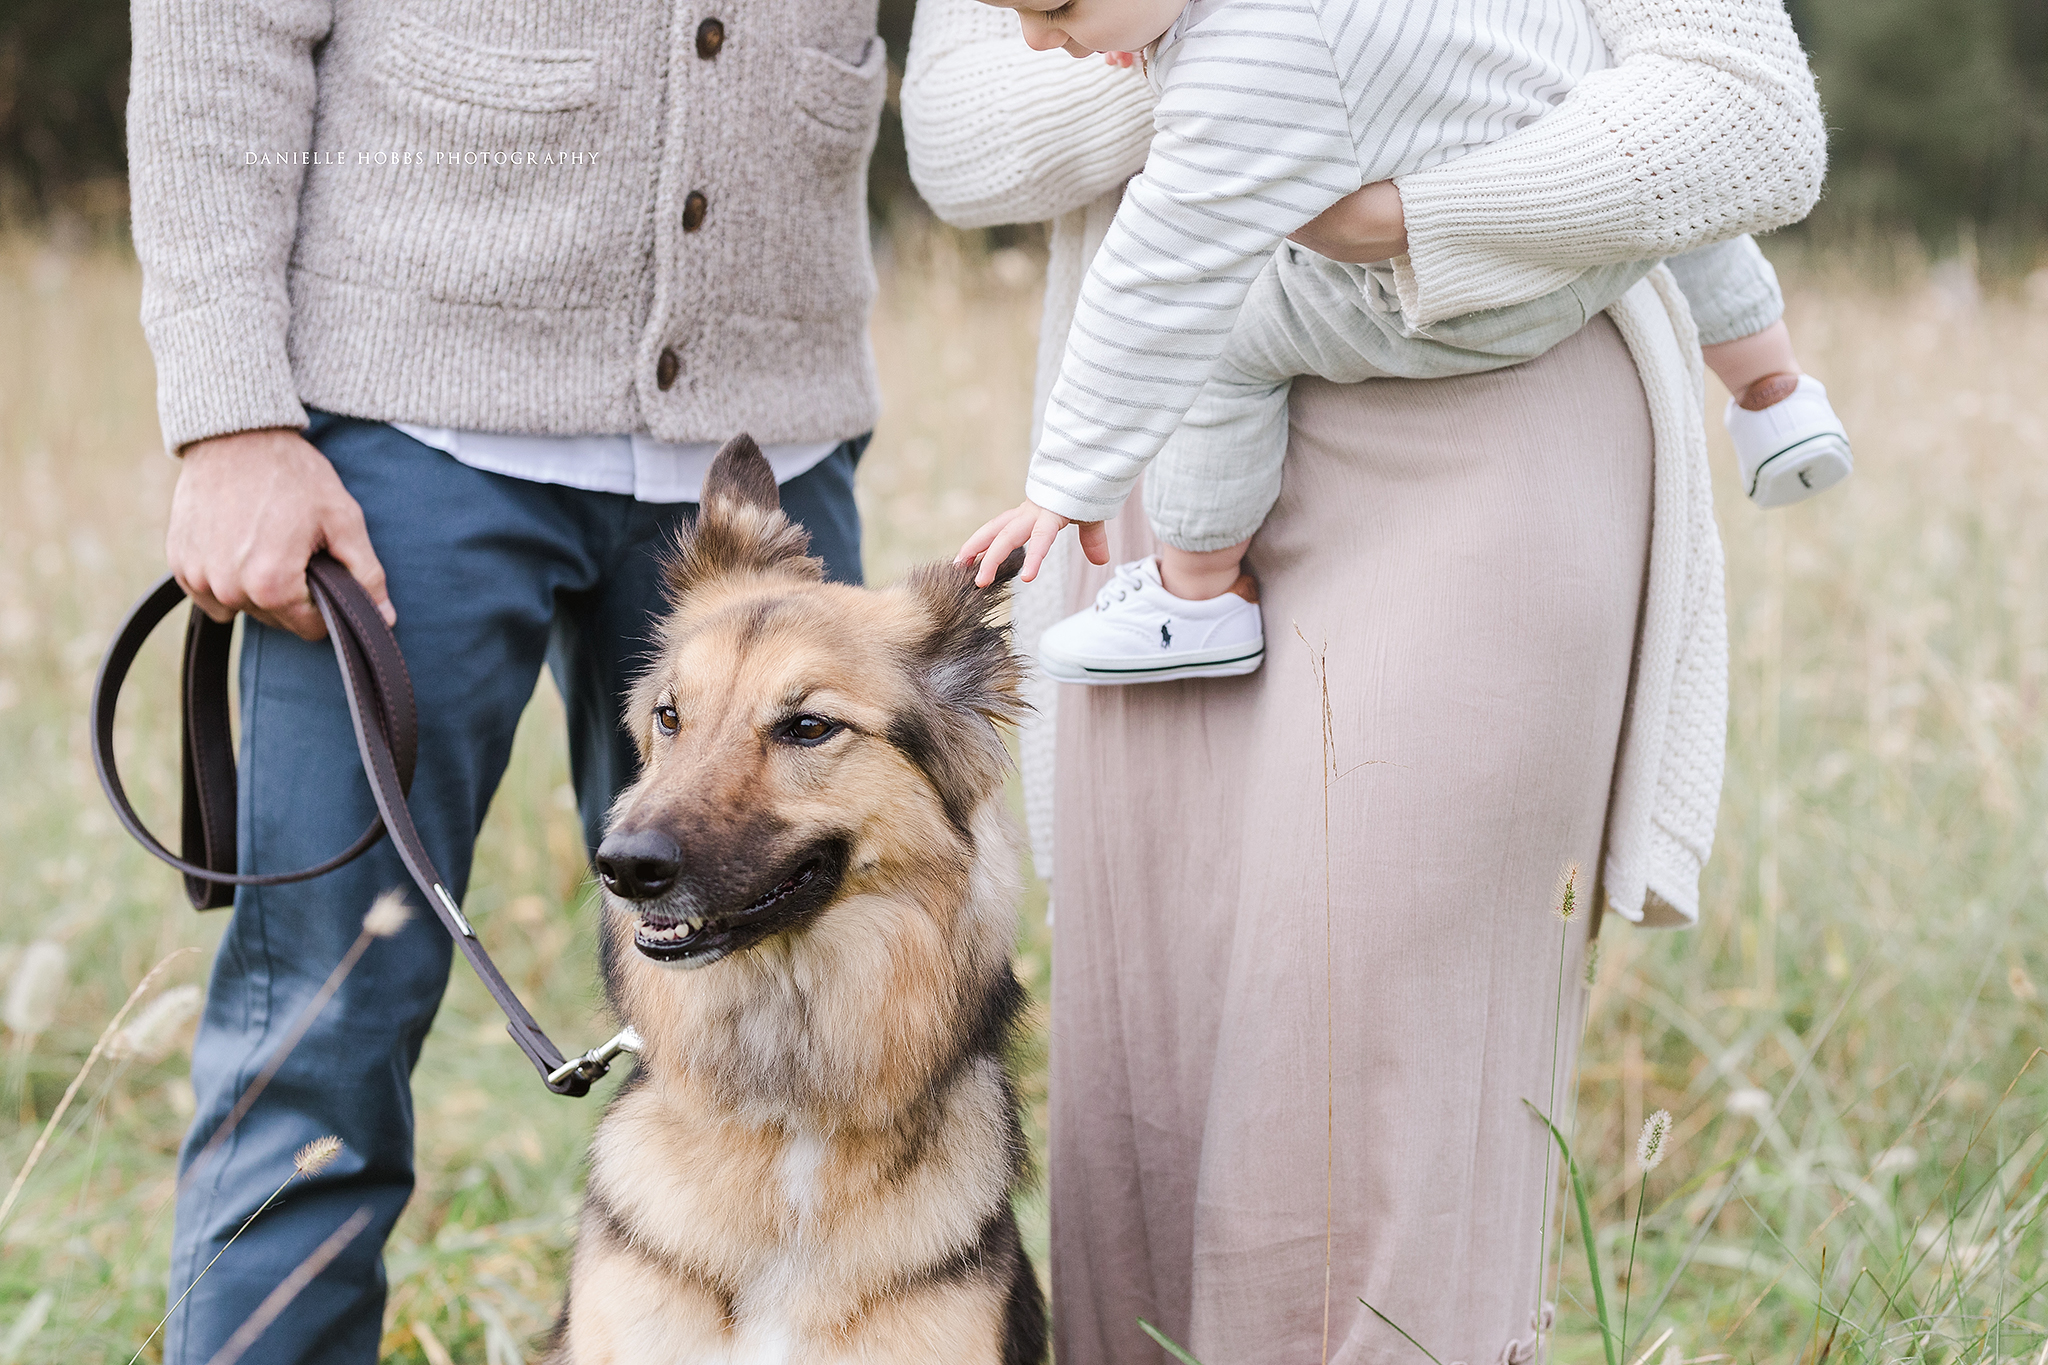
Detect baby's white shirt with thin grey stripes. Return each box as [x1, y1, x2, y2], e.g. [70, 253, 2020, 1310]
[1026, 0, 1608, 522]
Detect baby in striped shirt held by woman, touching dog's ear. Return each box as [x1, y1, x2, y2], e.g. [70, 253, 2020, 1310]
[961, 0, 1851, 684]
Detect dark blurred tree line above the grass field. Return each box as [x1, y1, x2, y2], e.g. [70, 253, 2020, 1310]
[0, 0, 2048, 246]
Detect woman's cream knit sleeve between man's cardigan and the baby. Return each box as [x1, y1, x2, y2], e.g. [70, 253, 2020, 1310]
[903, 0, 1153, 227]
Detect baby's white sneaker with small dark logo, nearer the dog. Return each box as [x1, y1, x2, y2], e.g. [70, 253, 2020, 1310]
[1038, 559, 1266, 686]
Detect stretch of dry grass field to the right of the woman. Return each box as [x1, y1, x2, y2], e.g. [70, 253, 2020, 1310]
[1563, 260, 2048, 1361]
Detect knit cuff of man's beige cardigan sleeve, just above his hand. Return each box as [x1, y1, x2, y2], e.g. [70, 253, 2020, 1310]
[143, 295, 305, 450]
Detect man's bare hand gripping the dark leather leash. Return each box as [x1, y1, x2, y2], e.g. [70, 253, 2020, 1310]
[164, 428, 397, 641]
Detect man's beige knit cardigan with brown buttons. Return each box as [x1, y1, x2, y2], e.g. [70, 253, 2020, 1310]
[129, 0, 887, 448]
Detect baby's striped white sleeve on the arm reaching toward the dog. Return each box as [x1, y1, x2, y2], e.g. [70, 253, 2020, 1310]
[1026, 0, 1360, 522]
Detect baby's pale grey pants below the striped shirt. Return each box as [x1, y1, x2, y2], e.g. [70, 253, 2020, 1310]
[1145, 237, 1784, 551]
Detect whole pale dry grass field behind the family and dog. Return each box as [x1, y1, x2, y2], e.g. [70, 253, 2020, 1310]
[0, 237, 2048, 1365]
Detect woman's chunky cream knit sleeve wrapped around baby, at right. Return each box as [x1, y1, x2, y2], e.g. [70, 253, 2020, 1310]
[1395, 0, 1827, 327]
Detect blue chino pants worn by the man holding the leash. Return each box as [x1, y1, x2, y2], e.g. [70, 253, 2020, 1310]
[164, 413, 866, 1365]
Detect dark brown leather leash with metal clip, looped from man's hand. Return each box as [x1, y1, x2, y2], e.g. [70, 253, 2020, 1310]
[92, 553, 639, 1097]
